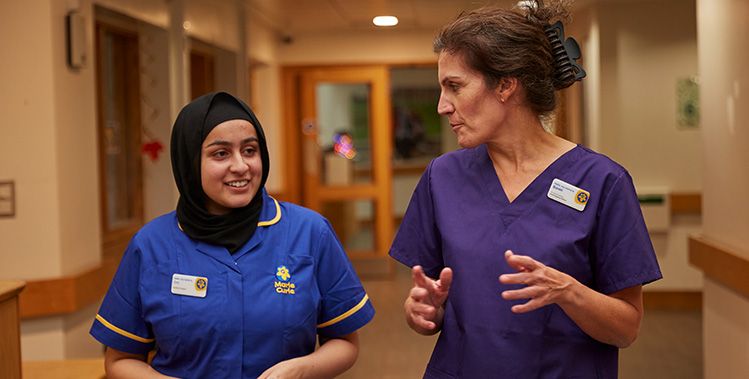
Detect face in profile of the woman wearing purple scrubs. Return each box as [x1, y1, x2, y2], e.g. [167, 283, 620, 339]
[437, 52, 506, 148]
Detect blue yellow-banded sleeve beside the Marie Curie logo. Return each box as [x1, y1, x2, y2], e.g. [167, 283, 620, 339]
[316, 221, 375, 337]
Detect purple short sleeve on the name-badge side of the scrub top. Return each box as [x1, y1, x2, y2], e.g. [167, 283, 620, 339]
[591, 171, 663, 294]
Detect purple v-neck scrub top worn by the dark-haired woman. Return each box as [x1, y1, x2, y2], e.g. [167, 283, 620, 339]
[390, 145, 662, 378]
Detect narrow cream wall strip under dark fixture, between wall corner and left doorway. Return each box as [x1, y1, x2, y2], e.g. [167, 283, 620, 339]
[50, 1, 101, 275]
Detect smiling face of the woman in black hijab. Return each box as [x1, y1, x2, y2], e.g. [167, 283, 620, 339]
[200, 120, 263, 215]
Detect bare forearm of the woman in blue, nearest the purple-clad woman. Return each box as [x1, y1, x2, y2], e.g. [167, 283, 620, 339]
[258, 332, 359, 379]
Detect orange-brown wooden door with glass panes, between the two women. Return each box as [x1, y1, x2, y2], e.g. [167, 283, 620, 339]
[299, 66, 393, 271]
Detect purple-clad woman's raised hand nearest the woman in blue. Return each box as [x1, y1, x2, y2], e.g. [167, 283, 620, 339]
[403, 266, 453, 335]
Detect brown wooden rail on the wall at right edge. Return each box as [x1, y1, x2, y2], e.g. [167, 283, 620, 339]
[689, 236, 749, 298]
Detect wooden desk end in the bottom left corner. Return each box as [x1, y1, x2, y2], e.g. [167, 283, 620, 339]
[0, 280, 26, 379]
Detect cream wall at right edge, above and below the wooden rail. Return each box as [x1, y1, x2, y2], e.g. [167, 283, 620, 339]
[697, 0, 749, 379]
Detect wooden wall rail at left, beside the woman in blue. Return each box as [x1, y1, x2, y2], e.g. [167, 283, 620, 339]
[19, 258, 119, 319]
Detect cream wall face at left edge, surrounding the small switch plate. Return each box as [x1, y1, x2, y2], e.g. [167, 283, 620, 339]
[0, 0, 65, 279]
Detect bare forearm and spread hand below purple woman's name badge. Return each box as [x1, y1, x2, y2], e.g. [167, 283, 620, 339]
[499, 250, 643, 348]
